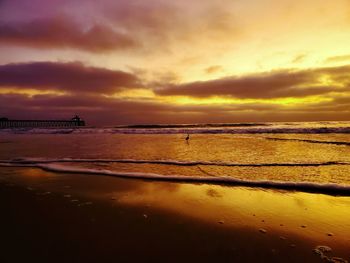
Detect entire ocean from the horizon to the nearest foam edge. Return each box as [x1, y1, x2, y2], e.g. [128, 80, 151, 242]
[0, 122, 350, 195]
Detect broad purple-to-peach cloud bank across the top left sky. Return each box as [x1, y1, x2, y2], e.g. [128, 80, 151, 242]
[0, 0, 237, 53]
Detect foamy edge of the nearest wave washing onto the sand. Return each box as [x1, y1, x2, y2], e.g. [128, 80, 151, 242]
[0, 161, 350, 195]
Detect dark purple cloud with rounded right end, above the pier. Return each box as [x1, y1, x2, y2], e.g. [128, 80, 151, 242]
[0, 62, 138, 93]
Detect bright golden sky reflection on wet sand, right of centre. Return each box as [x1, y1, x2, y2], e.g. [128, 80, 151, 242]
[113, 182, 350, 245]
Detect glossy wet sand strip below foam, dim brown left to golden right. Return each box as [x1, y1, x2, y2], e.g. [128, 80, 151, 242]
[12, 168, 350, 246]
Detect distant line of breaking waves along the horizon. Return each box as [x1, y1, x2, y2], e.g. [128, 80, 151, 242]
[0, 122, 350, 134]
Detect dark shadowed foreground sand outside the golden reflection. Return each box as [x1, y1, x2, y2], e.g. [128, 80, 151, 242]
[0, 169, 350, 263]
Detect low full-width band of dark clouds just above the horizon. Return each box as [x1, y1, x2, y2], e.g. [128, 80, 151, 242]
[0, 62, 350, 125]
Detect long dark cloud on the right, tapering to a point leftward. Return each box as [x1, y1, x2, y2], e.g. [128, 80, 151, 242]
[156, 66, 350, 99]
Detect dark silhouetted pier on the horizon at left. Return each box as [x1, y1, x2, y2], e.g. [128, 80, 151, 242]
[0, 115, 85, 129]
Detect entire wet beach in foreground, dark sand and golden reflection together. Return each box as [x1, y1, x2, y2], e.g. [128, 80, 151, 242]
[0, 168, 350, 262]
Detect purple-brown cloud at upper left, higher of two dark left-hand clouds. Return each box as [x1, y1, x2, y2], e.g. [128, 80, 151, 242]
[0, 16, 138, 52]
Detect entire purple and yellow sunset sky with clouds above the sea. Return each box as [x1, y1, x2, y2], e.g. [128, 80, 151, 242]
[0, 0, 350, 125]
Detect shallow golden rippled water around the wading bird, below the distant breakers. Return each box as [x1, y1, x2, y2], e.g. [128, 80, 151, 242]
[0, 133, 350, 193]
